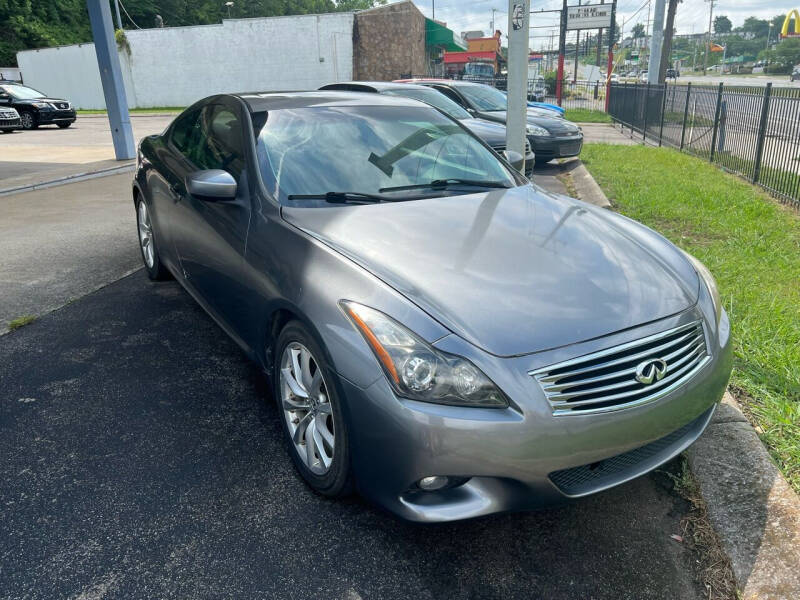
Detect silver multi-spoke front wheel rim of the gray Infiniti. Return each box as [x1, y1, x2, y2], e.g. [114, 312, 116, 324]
[280, 342, 335, 475]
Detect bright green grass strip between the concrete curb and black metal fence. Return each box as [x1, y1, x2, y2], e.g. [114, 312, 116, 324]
[581, 144, 800, 492]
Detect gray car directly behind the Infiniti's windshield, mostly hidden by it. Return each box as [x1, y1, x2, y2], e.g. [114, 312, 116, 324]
[319, 81, 536, 177]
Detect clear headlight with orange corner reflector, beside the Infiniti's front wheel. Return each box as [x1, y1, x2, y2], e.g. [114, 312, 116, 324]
[339, 300, 508, 408]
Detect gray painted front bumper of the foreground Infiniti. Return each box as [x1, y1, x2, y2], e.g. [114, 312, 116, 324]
[342, 310, 731, 522]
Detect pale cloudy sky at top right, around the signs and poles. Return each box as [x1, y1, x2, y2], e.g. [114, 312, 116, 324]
[415, 0, 800, 48]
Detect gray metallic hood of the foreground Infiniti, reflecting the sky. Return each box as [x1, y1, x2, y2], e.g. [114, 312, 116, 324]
[282, 185, 699, 356]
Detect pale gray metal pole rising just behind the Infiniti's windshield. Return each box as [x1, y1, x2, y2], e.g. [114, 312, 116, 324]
[506, 0, 531, 172]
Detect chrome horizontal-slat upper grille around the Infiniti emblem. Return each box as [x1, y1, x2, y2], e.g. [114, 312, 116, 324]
[530, 321, 711, 415]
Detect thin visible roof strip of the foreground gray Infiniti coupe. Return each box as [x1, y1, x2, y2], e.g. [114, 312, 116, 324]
[232, 90, 424, 112]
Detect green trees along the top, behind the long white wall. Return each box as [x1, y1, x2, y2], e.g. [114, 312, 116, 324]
[0, 0, 386, 66]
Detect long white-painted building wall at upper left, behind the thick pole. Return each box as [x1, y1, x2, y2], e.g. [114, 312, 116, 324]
[17, 13, 354, 108]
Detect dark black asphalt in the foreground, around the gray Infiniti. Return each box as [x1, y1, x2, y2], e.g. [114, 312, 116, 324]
[0, 271, 703, 599]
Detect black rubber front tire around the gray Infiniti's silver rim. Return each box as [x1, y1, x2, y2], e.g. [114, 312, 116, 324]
[272, 321, 352, 497]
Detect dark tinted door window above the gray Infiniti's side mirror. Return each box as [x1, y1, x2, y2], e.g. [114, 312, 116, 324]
[172, 104, 245, 179]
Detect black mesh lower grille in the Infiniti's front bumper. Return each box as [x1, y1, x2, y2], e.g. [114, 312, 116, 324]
[548, 408, 713, 496]
